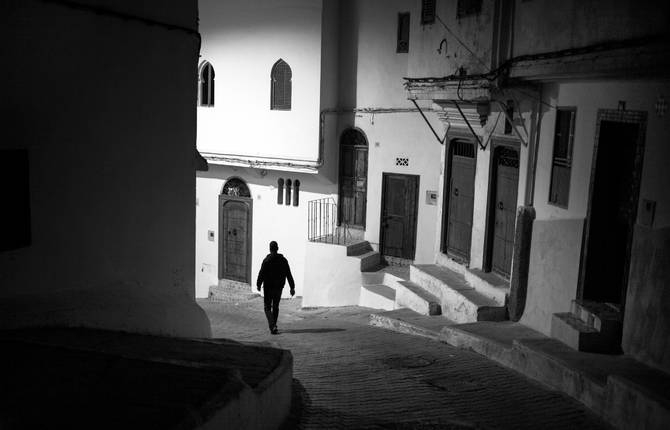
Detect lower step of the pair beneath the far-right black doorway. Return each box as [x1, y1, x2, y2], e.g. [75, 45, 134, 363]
[551, 312, 621, 354]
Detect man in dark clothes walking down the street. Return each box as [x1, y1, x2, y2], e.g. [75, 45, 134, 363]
[256, 240, 295, 334]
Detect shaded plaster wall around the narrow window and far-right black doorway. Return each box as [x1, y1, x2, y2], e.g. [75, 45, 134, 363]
[522, 81, 670, 333]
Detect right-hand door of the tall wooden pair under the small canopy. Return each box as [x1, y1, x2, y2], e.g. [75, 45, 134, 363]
[491, 146, 519, 279]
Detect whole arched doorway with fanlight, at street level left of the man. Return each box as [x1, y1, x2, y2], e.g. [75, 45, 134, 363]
[219, 178, 253, 283]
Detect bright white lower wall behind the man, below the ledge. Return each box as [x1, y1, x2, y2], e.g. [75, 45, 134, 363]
[195, 165, 335, 297]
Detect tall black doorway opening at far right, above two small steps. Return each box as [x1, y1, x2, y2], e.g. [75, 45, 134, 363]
[580, 115, 643, 313]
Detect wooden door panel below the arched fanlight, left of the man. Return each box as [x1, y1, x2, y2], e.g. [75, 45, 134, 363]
[219, 196, 251, 283]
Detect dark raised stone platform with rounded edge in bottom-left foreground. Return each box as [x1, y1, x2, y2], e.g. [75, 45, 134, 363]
[0, 328, 293, 429]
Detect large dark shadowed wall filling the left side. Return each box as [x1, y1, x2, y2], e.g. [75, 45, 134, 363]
[0, 0, 210, 336]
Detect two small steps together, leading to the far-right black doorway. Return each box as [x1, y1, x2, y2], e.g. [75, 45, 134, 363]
[551, 300, 623, 354]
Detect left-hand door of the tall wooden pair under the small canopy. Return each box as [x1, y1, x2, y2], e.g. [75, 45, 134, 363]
[444, 140, 475, 261]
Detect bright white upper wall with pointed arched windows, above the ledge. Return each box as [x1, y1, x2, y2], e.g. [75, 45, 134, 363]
[198, 0, 322, 160]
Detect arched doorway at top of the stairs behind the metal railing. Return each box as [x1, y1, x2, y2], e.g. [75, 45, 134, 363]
[338, 128, 368, 229]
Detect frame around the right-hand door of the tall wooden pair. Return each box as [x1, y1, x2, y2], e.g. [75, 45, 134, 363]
[482, 136, 521, 273]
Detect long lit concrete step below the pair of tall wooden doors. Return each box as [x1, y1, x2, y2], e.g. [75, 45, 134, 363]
[410, 264, 506, 323]
